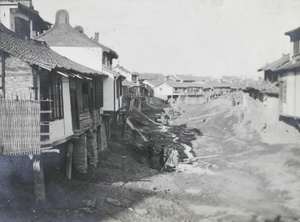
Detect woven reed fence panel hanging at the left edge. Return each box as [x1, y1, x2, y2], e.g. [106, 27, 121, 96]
[0, 99, 41, 155]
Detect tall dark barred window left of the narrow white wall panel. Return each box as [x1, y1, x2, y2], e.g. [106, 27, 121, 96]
[50, 74, 64, 119]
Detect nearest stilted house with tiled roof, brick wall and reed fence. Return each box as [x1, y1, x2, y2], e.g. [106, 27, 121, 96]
[0, 24, 107, 200]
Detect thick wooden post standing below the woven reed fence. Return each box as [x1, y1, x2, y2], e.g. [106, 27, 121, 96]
[33, 159, 46, 202]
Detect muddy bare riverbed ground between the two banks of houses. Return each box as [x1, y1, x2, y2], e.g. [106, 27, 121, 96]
[0, 99, 300, 222]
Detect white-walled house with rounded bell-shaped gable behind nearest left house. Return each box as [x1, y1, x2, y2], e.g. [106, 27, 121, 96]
[36, 10, 125, 138]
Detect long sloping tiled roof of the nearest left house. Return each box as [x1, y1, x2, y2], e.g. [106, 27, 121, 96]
[0, 24, 105, 76]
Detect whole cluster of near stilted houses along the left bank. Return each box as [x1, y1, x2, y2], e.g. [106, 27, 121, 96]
[0, 0, 126, 200]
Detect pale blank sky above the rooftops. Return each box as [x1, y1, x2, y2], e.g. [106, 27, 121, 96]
[32, 0, 300, 78]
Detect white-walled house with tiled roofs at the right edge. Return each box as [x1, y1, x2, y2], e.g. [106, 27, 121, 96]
[248, 24, 300, 120]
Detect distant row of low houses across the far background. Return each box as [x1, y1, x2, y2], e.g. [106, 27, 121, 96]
[116, 67, 245, 102]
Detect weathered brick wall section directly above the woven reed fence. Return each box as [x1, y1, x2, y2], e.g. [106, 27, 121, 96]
[5, 56, 34, 100]
